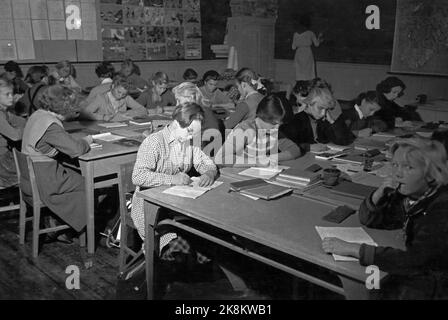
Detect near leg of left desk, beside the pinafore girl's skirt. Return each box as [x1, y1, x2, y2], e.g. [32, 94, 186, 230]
[81, 161, 95, 255]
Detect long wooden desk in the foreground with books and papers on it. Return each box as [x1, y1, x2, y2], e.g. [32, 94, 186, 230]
[137, 177, 403, 299]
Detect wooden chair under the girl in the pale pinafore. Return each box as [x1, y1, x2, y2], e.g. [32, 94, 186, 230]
[13, 149, 70, 258]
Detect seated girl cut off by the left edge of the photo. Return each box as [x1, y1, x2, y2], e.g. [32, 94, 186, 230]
[0, 78, 25, 189]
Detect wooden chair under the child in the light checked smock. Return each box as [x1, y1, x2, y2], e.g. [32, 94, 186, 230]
[118, 162, 144, 278]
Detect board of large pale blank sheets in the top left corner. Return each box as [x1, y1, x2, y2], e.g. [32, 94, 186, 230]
[0, 0, 102, 63]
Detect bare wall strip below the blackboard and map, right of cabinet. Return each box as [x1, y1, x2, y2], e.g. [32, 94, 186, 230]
[275, 60, 448, 104]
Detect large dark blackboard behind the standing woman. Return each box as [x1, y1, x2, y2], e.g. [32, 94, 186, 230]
[275, 0, 396, 65]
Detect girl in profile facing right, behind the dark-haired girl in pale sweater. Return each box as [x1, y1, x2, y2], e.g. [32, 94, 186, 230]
[224, 68, 264, 129]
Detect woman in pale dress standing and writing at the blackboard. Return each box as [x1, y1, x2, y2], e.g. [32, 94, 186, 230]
[292, 15, 323, 81]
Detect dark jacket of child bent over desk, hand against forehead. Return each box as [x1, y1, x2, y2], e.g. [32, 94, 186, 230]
[280, 112, 355, 152]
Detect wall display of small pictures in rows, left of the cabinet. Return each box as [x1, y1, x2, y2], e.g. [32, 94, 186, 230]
[100, 0, 202, 61]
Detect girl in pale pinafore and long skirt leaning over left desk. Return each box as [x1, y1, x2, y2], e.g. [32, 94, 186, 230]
[22, 85, 92, 236]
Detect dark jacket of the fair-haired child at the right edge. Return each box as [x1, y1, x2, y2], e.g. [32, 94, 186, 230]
[359, 186, 448, 299]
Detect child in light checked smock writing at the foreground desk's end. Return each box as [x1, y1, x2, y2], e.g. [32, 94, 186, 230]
[131, 103, 217, 263]
